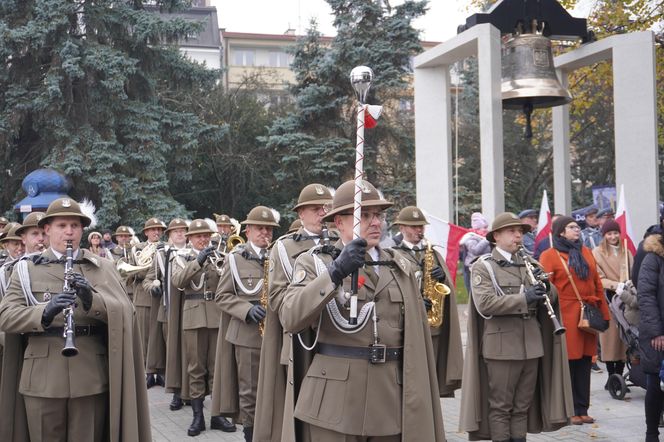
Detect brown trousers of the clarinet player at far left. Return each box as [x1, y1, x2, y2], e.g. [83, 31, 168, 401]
[23, 393, 108, 442]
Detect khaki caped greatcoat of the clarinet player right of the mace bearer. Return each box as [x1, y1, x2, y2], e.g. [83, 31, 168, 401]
[459, 249, 573, 440]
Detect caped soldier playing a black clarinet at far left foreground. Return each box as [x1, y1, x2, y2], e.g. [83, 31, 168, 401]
[0, 198, 151, 441]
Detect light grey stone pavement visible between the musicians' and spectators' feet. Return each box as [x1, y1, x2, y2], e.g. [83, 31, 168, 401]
[148, 305, 645, 442]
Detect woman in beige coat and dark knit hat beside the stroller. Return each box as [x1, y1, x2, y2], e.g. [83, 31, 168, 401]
[593, 219, 633, 390]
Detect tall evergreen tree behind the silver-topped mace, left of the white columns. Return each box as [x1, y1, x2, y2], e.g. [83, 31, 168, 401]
[261, 0, 426, 218]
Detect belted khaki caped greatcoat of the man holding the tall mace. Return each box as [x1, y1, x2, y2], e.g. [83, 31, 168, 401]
[279, 242, 445, 442]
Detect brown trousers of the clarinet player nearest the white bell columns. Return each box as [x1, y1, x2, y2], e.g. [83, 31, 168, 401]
[485, 359, 539, 440]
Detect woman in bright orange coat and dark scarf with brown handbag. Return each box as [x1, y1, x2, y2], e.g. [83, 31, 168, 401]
[540, 216, 609, 425]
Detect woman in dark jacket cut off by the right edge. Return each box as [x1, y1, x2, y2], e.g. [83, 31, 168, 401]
[638, 234, 664, 442]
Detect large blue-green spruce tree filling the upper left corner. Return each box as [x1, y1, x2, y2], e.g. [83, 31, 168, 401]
[0, 0, 222, 226]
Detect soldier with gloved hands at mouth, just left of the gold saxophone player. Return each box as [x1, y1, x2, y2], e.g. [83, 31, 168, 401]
[171, 219, 228, 436]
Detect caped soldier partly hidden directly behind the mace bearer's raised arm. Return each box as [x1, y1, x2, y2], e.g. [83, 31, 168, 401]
[254, 183, 336, 442]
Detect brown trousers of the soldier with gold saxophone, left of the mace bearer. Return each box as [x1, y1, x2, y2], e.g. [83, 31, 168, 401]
[234, 345, 261, 427]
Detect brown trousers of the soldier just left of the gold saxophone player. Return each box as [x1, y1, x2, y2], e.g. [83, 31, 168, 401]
[183, 328, 219, 399]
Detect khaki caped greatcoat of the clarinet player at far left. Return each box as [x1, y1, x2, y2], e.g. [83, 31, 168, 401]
[0, 249, 152, 442]
